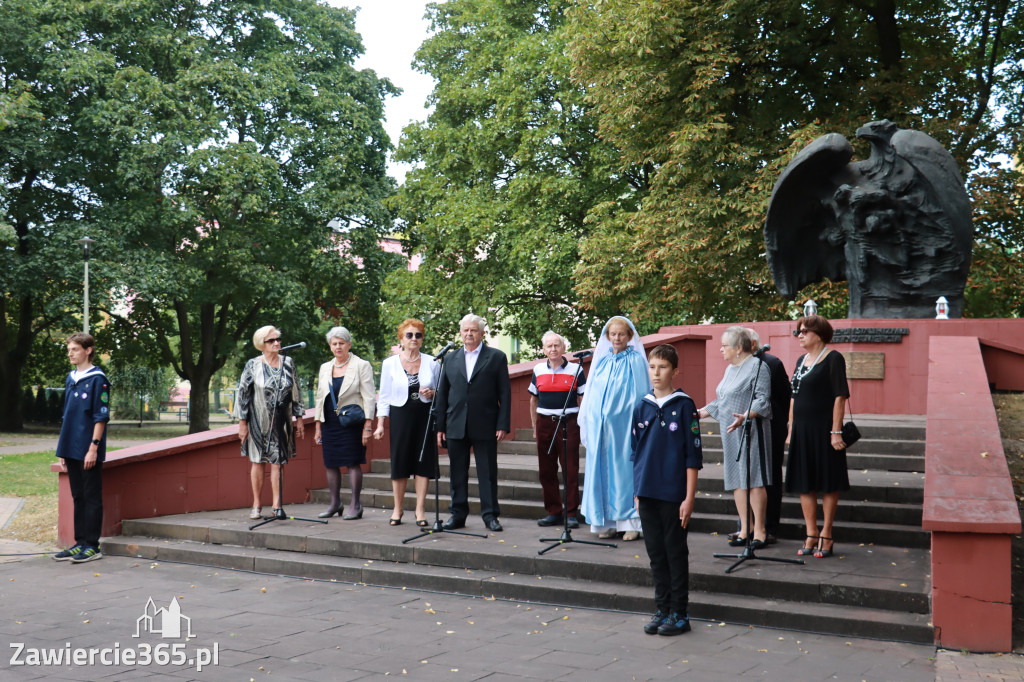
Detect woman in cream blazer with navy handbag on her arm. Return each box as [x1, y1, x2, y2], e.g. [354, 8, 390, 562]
[313, 327, 376, 521]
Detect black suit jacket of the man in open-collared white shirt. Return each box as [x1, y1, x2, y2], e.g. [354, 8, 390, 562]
[434, 344, 512, 440]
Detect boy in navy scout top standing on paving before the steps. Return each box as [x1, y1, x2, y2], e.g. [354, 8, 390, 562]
[631, 344, 703, 636]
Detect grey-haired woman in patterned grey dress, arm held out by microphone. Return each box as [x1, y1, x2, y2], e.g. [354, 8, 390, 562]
[699, 327, 772, 549]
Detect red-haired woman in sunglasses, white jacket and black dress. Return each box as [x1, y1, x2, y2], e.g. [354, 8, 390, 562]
[374, 318, 440, 527]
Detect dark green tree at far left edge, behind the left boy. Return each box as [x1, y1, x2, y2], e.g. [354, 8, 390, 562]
[0, 0, 118, 431]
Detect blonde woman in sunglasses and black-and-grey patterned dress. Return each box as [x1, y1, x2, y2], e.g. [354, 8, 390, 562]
[234, 325, 305, 519]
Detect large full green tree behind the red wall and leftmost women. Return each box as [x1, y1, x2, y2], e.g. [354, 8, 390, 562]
[0, 0, 395, 432]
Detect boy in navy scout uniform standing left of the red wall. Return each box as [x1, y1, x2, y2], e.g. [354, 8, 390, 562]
[53, 333, 111, 563]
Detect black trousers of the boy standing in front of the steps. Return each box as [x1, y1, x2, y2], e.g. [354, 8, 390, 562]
[639, 498, 690, 614]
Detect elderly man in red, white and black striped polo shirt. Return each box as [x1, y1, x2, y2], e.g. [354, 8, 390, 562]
[527, 332, 587, 528]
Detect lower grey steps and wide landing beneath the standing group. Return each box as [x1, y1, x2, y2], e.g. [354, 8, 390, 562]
[102, 505, 932, 642]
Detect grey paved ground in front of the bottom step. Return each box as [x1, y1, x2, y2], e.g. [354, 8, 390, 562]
[0, 541, 1024, 682]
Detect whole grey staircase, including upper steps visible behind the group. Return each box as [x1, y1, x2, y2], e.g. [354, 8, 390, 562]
[103, 416, 933, 643]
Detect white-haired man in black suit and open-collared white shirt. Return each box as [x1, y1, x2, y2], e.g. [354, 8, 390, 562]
[434, 314, 512, 531]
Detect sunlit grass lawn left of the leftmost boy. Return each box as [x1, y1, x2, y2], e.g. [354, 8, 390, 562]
[0, 451, 57, 547]
